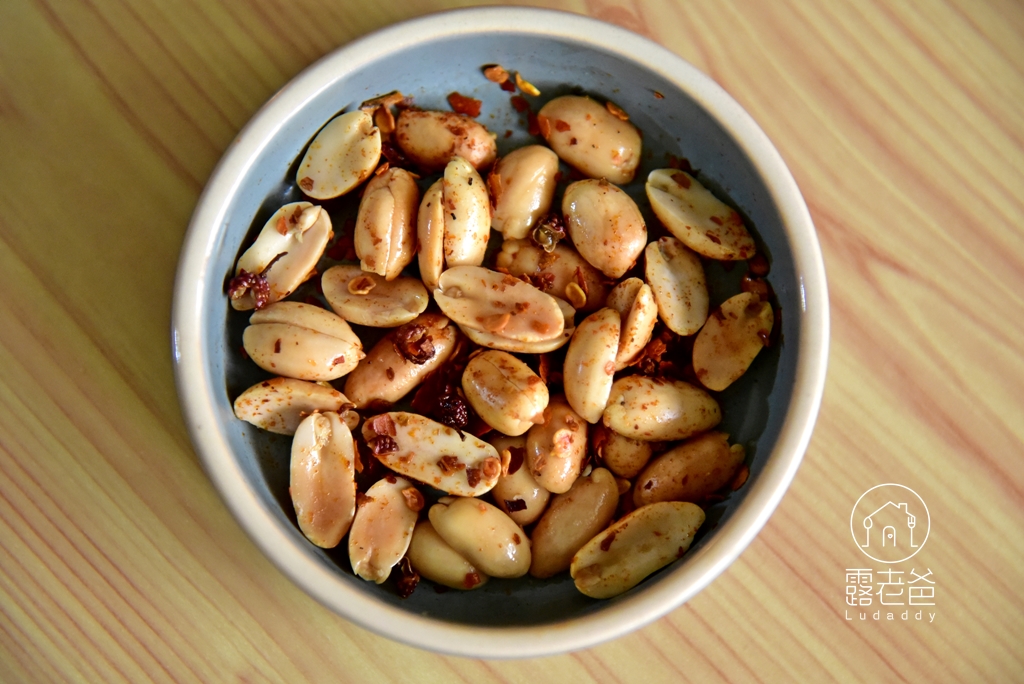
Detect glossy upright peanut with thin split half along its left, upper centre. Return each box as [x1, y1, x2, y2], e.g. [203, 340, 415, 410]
[441, 157, 490, 266]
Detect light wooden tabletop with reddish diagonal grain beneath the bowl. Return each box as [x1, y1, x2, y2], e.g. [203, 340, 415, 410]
[0, 0, 1024, 684]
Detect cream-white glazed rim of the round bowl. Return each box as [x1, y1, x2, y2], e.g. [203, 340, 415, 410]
[172, 7, 828, 658]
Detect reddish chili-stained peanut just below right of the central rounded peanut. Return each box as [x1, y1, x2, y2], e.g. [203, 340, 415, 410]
[526, 396, 587, 494]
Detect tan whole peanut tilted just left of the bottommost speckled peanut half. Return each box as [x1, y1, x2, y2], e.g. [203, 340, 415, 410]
[529, 468, 618, 579]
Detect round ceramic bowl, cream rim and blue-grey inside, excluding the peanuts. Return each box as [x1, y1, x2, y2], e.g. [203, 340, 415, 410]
[173, 8, 828, 657]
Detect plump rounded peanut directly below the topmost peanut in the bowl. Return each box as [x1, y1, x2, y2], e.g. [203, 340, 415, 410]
[562, 179, 647, 279]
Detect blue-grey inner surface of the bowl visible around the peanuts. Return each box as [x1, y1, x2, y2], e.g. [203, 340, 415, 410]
[205, 34, 801, 626]
